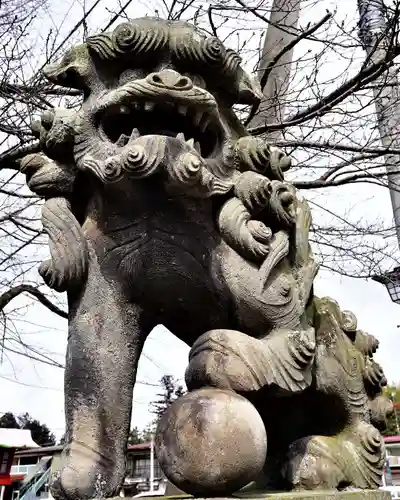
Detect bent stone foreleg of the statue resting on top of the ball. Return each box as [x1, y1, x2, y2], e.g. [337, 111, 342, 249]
[185, 328, 315, 393]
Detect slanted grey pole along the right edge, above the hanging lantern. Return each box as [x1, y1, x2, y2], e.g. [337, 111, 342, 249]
[358, 0, 400, 245]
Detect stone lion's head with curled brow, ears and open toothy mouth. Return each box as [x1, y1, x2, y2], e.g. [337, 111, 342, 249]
[40, 17, 288, 189]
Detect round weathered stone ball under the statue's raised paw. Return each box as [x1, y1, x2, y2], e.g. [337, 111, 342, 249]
[155, 388, 267, 496]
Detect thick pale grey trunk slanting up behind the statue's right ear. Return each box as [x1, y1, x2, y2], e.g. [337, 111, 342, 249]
[251, 0, 301, 141]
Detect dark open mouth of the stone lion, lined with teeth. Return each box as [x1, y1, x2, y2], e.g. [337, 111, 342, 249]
[99, 102, 222, 158]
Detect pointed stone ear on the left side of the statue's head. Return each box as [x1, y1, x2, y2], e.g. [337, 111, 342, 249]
[43, 45, 92, 90]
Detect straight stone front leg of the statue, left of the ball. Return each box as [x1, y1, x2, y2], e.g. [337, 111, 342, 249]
[52, 252, 148, 500]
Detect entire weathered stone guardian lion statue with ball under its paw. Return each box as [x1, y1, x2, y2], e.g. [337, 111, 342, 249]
[21, 18, 392, 499]
